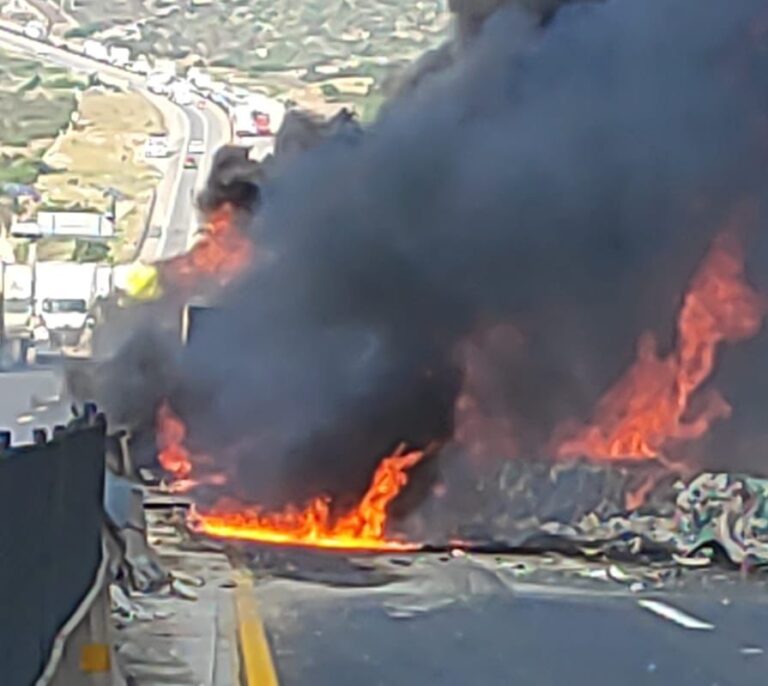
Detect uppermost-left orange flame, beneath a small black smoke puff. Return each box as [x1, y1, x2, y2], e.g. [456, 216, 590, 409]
[161, 203, 254, 285]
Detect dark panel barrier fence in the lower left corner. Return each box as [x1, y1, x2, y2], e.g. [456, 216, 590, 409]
[0, 413, 106, 686]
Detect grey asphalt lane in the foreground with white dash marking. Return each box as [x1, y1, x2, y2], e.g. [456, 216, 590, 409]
[241, 555, 768, 686]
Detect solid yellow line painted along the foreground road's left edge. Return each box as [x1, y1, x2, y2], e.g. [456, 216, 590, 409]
[235, 572, 279, 686]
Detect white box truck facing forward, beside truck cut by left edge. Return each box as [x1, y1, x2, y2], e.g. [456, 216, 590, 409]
[34, 262, 100, 350]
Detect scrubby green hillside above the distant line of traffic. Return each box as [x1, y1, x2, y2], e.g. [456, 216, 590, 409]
[64, 0, 449, 118]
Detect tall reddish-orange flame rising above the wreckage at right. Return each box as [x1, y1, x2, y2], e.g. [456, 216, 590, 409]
[556, 233, 766, 459]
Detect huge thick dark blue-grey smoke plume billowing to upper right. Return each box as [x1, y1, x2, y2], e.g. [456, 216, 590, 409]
[166, 0, 768, 504]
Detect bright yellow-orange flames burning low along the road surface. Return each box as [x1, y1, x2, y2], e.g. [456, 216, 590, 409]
[194, 451, 424, 550]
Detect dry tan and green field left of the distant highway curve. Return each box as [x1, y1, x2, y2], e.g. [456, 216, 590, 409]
[0, 52, 164, 261]
